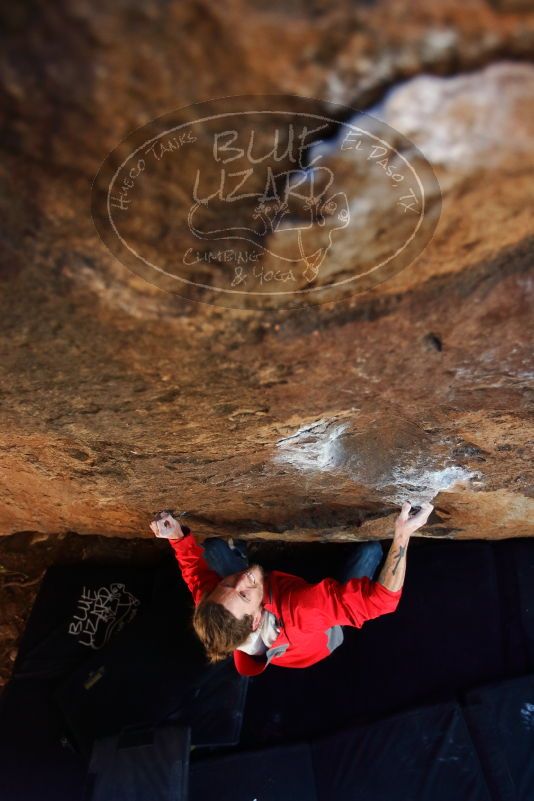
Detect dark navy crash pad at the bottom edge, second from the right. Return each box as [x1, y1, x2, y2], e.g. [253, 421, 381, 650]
[312, 703, 492, 801]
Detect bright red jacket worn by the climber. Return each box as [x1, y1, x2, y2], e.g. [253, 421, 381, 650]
[169, 534, 402, 676]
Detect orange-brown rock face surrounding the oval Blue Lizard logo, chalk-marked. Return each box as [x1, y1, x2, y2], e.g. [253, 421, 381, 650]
[0, 0, 534, 540]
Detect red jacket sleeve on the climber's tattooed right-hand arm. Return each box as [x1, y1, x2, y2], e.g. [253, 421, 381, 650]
[291, 578, 402, 628]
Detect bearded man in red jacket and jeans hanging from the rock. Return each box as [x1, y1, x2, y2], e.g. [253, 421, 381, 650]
[150, 501, 434, 676]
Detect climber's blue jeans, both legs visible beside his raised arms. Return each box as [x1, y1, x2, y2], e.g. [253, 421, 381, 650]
[204, 537, 383, 582]
